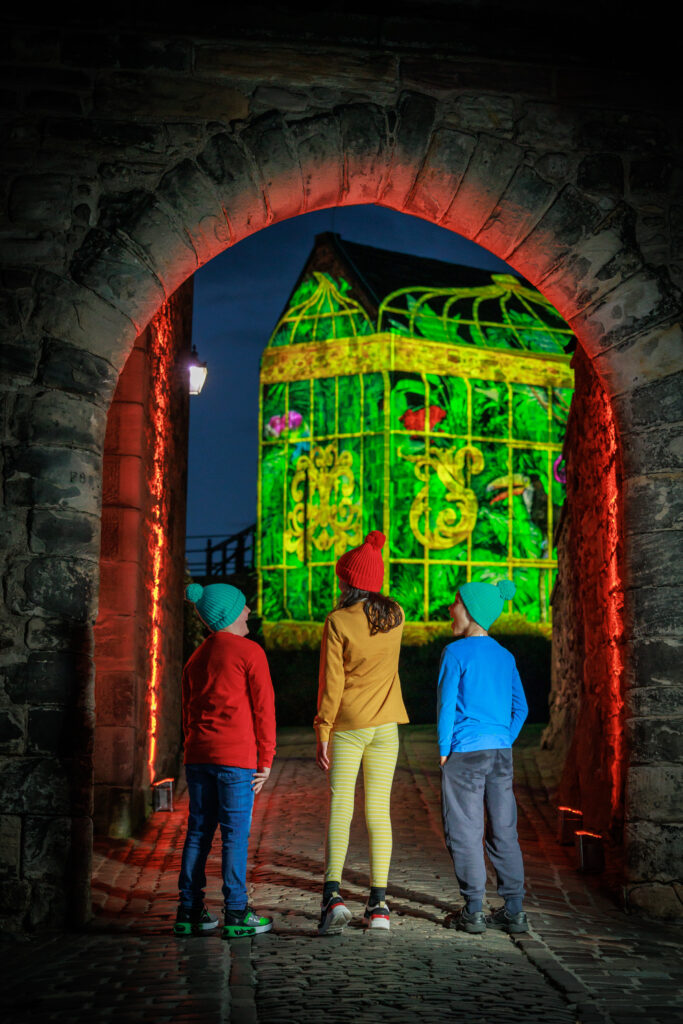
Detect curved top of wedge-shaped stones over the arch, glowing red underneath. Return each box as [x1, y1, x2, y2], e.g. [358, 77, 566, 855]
[65, 93, 661, 403]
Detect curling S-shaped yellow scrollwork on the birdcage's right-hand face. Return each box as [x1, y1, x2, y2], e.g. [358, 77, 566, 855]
[398, 444, 484, 551]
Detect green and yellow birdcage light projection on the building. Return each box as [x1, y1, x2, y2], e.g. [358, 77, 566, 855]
[257, 271, 573, 646]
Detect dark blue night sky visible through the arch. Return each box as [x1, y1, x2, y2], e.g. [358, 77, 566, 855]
[187, 206, 516, 539]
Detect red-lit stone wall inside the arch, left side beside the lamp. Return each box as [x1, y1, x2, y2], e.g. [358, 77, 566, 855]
[94, 279, 193, 836]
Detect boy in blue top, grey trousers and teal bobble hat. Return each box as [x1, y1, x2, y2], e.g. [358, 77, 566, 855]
[436, 580, 528, 934]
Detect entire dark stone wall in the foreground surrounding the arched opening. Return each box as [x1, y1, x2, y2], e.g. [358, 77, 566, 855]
[0, 9, 683, 926]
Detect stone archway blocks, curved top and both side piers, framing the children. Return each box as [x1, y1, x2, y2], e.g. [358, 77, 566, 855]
[4, 83, 683, 920]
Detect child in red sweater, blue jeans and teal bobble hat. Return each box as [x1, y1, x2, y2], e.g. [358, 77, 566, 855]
[174, 583, 275, 939]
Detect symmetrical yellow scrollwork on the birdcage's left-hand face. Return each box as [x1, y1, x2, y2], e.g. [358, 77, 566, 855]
[285, 444, 361, 562]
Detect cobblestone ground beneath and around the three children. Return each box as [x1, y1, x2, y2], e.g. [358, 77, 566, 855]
[1, 726, 683, 1024]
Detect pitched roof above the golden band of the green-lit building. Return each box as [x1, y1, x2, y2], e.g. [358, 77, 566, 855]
[269, 231, 574, 354]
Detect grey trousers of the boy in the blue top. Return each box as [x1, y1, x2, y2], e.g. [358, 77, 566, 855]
[441, 750, 524, 900]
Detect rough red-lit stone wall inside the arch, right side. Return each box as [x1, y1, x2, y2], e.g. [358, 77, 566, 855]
[544, 350, 626, 839]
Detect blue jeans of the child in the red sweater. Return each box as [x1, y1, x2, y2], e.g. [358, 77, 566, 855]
[178, 765, 255, 911]
